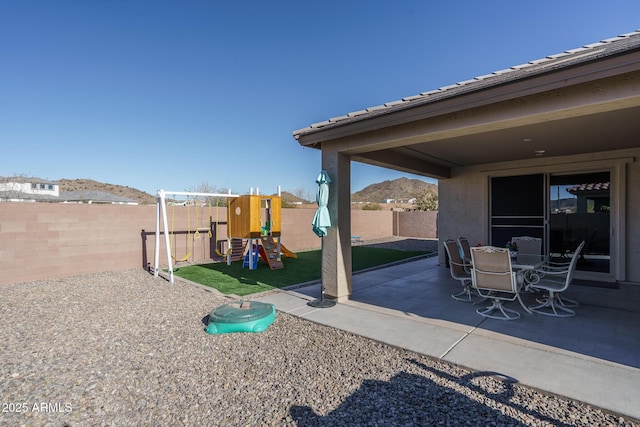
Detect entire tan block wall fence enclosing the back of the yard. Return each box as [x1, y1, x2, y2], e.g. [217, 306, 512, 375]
[0, 202, 437, 285]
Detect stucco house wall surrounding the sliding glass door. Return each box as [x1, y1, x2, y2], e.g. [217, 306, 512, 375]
[438, 148, 640, 283]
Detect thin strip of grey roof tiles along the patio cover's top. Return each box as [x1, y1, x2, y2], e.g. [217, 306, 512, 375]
[293, 29, 640, 139]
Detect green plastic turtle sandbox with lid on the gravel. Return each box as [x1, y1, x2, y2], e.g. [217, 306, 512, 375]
[205, 301, 276, 334]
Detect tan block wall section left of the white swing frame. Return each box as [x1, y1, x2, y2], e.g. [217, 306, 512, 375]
[0, 202, 155, 285]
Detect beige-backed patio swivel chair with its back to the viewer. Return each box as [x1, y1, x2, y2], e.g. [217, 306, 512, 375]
[471, 246, 520, 320]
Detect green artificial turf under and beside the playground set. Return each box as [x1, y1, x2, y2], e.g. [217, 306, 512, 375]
[174, 246, 427, 296]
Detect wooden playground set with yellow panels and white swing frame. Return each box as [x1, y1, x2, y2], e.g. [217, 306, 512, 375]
[154, 190, 296, 283]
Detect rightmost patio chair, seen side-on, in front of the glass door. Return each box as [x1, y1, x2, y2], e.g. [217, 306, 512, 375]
[529, 240, 585, 317]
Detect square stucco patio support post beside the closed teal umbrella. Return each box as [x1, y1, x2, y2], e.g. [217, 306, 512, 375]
[322, 146, 351, 302]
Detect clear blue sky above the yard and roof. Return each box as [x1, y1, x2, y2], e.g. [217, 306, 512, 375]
[0, 0, 640, 199]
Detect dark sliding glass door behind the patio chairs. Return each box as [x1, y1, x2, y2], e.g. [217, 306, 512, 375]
[489, 171, 612, 279]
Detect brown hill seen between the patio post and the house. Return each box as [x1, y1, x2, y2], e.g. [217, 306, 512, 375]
[351, 178, 438, 203]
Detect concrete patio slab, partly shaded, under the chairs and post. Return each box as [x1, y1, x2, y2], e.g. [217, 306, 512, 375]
[256, 257, 640, 420]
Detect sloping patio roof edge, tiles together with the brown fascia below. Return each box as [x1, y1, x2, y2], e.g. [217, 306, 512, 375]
[293, 31, 640, 149]
